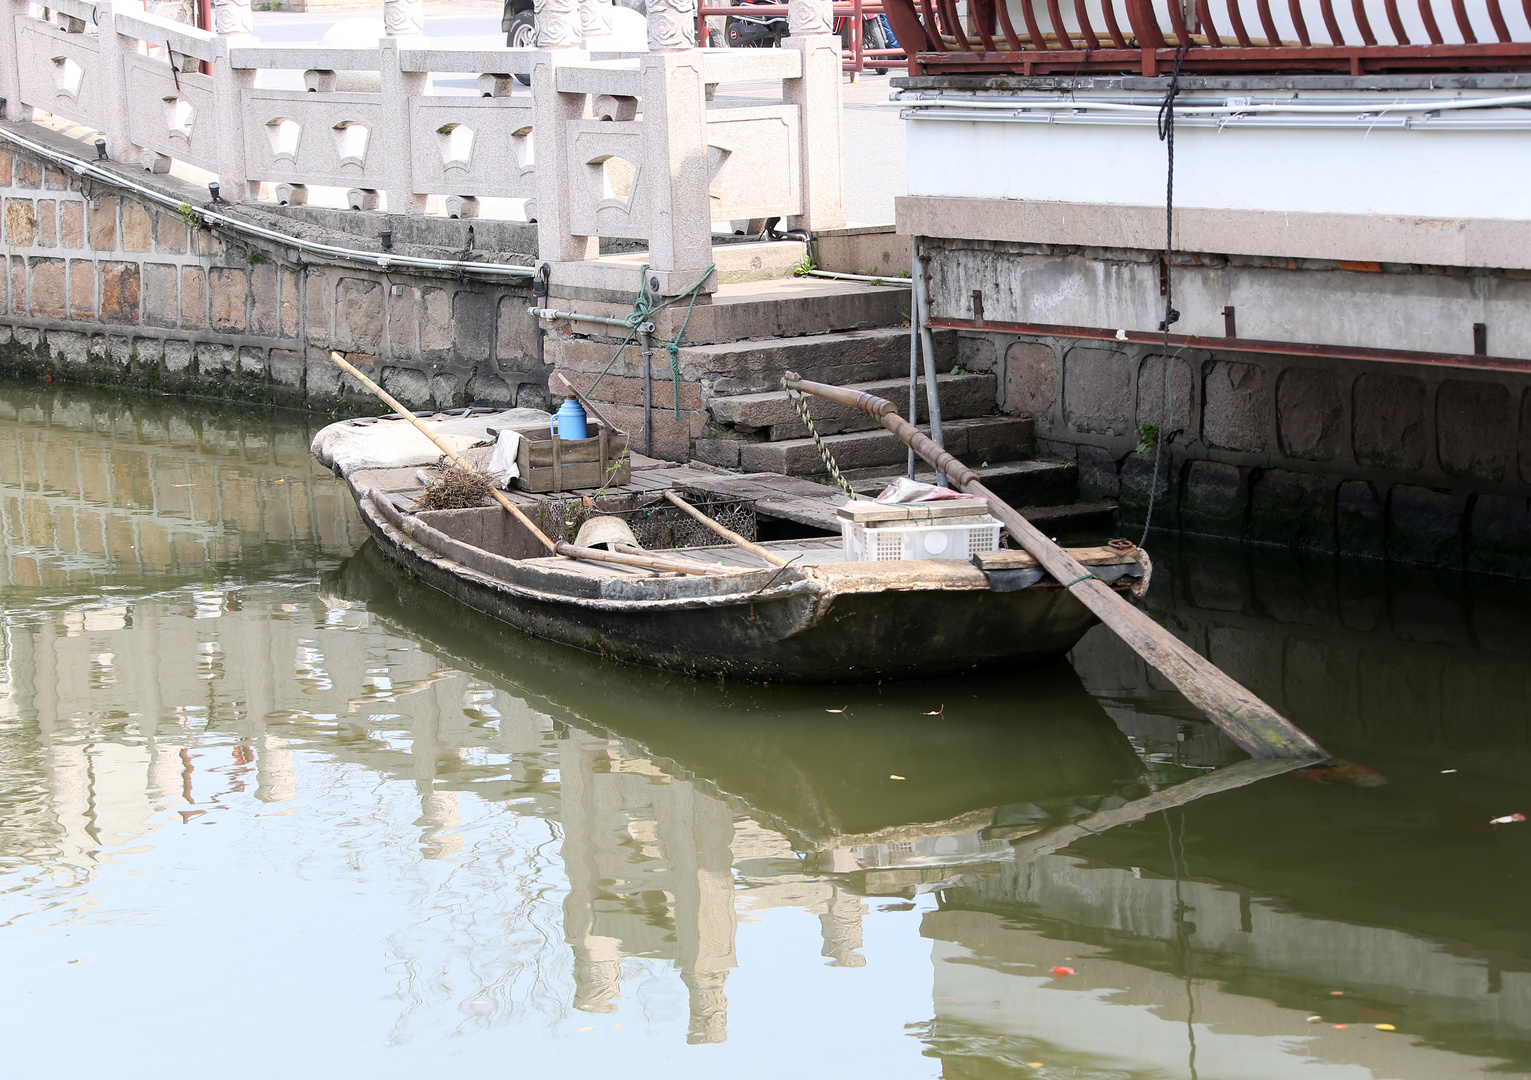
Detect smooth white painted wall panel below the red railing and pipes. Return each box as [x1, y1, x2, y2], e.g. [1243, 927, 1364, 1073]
[908, 109, 1531, 221]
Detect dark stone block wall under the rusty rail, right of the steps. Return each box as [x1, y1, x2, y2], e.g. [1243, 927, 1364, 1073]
[961, 320, 1531, 576]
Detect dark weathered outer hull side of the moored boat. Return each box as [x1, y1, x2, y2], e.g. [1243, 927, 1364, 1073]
[358, 495, 1126, 683]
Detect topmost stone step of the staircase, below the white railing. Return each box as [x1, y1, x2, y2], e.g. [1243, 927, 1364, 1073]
[548, 276, 909, 343]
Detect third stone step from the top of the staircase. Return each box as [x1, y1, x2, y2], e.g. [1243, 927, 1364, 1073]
[707, 372, 995, 443]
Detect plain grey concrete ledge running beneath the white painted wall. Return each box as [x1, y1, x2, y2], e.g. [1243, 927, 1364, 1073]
[896, 195, 1531, 270]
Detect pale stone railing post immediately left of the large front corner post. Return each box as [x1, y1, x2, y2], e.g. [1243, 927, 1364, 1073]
[531, 0, 600, 262]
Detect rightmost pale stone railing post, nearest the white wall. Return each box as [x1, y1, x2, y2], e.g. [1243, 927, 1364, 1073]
[782, 0, 845, 231]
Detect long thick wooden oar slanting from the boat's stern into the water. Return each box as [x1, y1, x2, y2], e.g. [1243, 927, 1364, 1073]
[782, 371, 1329, 758]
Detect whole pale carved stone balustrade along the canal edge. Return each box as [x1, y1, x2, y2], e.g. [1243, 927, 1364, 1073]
[0, 0, 844, 294]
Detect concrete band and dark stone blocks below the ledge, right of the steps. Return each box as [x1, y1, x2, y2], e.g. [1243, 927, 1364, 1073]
[928, 241, 1531, 576]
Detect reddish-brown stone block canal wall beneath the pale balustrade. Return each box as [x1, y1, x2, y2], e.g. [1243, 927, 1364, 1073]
[0, 143, 547, 412]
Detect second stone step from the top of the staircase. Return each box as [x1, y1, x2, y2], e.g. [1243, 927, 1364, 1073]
[544, 329, 955, 409]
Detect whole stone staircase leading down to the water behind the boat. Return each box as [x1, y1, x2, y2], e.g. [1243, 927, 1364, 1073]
[548, 277, 1115, 532]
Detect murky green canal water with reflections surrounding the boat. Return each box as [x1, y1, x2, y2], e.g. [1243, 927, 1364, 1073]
[0, 386, 1531, 1080]
